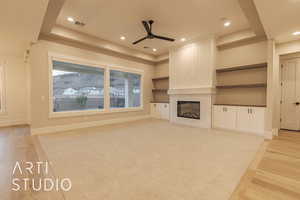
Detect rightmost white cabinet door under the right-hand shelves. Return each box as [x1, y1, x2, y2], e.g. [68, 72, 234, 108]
[250, 107, 265, 134]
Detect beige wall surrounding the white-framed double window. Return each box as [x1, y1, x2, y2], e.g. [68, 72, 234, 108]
[30, 41, 154, 128]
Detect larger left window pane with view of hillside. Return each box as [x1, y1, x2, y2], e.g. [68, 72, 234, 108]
[52, 60, 104, 112]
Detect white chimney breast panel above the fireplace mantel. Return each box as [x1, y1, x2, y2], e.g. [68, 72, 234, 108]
[169, 38, 216, 89]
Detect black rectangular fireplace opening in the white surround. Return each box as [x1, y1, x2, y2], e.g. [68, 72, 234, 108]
[177, 101, 200, 119]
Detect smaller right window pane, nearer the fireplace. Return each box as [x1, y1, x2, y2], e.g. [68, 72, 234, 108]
[109, 70, 141, 108]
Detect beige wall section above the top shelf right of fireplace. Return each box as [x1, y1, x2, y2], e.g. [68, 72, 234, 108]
[217, 41, 268, 68]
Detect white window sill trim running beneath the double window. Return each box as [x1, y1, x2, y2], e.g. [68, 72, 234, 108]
[49, 107, 144, 119]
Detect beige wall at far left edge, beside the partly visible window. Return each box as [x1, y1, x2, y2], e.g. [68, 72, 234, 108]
[0, 55, 29, 126]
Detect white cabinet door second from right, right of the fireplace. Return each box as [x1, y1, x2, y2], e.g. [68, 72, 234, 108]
[236, 107, 252, 132]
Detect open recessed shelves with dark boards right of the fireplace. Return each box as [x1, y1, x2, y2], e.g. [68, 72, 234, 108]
[216, 63, 268, 107]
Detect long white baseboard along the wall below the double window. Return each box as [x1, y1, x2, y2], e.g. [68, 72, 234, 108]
[31, 115, 151, 135]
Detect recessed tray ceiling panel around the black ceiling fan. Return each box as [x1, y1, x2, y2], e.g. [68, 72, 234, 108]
[57, 0, 249, 54]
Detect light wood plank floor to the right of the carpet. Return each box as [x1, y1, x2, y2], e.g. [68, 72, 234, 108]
[231, 131, 300, 200]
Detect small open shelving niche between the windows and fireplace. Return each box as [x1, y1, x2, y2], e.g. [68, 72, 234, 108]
[151, 76, 169, 103]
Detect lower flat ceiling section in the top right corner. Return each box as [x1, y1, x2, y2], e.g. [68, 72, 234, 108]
[254, 0, 300, 42]
